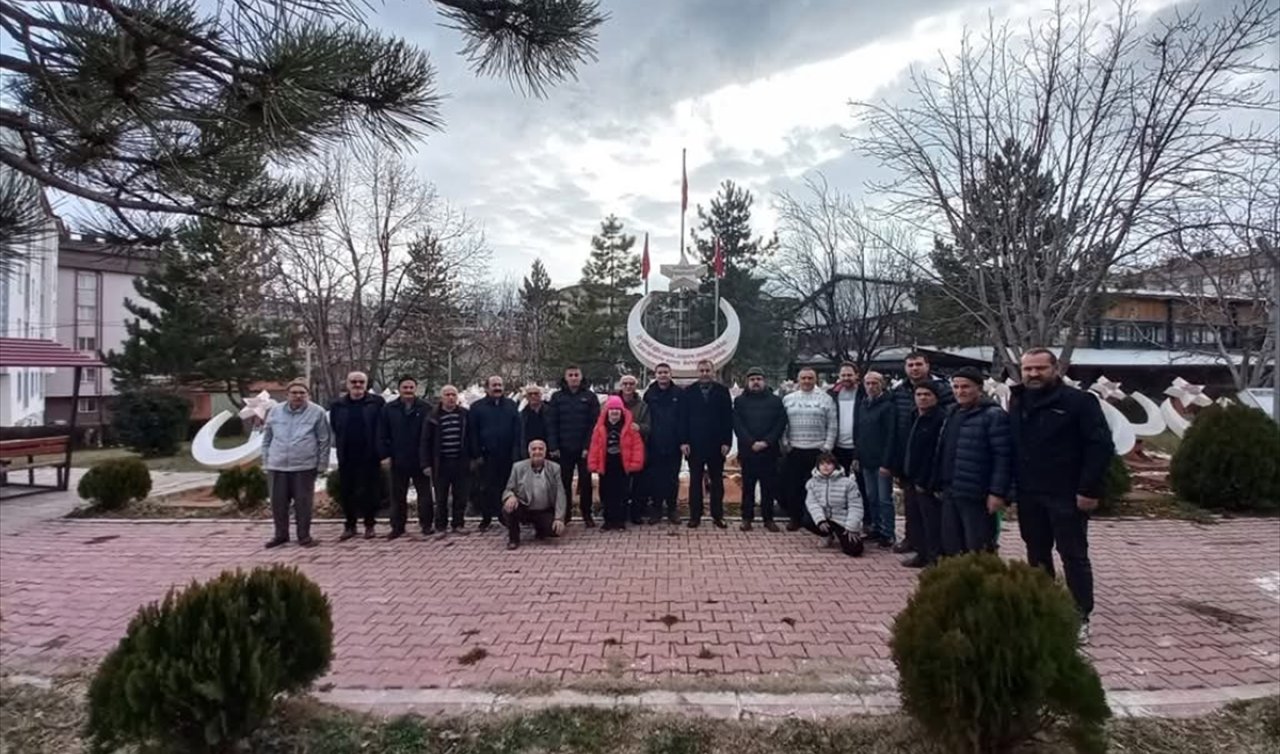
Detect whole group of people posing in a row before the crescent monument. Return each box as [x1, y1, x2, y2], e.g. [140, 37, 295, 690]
[262, 348, 1114, 632]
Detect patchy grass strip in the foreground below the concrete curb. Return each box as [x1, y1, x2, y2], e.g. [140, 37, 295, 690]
[0, 680, 1280, 754]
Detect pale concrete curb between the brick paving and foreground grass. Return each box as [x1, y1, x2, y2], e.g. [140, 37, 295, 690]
[312, 682, 1280, 721]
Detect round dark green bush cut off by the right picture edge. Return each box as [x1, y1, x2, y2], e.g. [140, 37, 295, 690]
[1169, 405, 1280, 512]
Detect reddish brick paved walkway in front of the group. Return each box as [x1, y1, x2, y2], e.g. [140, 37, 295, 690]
[0, 520, 1280, 690]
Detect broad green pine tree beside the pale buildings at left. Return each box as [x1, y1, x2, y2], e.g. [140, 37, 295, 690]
[106, 220, 294, 405]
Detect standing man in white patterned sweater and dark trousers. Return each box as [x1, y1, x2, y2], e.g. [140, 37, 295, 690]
[782, 367, 840, 531]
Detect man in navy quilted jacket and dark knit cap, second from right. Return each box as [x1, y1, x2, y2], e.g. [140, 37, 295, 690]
[934, 366, 1012, 556]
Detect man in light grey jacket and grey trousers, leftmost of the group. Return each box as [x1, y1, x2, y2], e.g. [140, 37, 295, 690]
[262, 380, 332, 548]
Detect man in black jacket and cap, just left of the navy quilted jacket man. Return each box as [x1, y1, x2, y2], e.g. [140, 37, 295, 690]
[895, 380, 945, 568]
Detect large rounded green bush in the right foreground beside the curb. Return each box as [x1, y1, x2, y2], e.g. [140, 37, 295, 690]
[890, 553, 1111, 754]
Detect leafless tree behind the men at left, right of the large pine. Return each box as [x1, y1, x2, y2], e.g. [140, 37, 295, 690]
[276, 143, 488, 396]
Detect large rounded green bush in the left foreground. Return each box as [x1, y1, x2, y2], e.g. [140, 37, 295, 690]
[87, 566, 333, 751]
